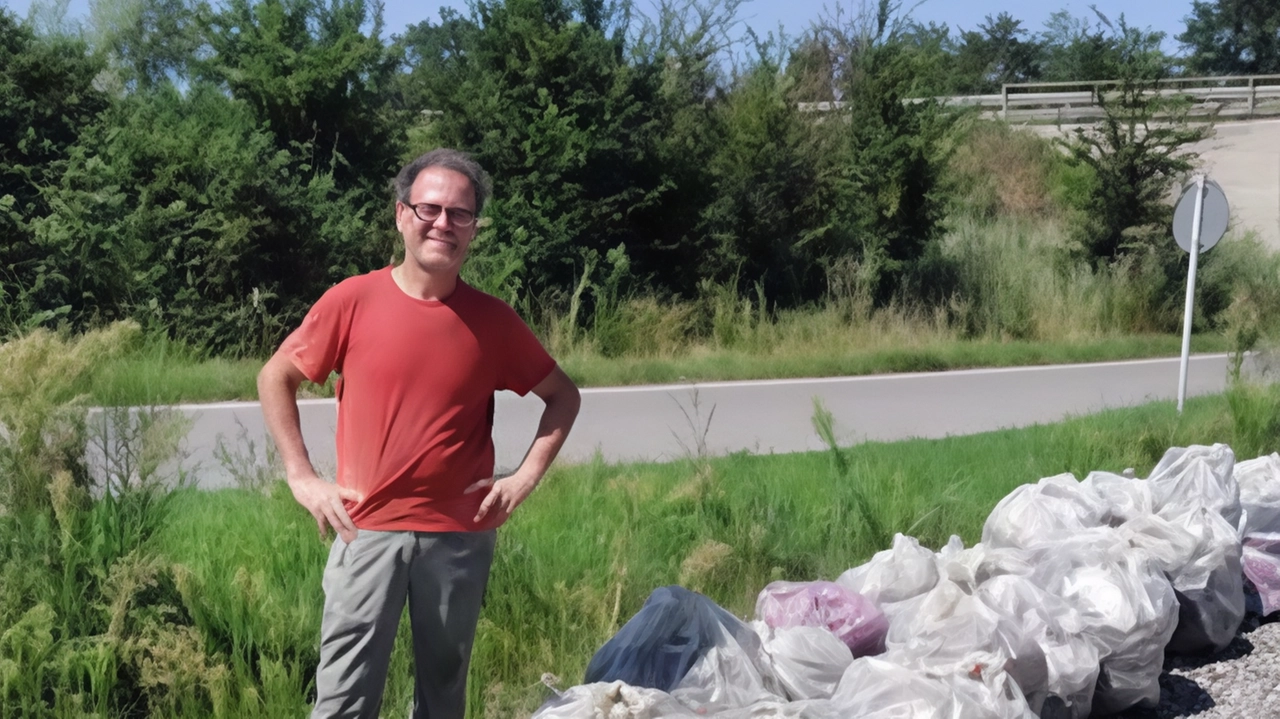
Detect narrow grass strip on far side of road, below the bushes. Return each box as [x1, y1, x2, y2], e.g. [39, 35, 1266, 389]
[81, 330, 1229, 407]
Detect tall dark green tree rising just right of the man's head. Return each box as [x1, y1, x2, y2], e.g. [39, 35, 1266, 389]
[406, 0, 658, 296]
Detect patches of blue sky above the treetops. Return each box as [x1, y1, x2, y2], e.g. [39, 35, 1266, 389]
[0, 0, 1192, 51]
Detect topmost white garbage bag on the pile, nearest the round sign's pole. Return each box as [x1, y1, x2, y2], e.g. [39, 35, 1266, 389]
[1147, 444, 1240, 527]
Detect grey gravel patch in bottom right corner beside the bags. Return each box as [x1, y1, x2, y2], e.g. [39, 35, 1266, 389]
[1116, 591, 1280, 719]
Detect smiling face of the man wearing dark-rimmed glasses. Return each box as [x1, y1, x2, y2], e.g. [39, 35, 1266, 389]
[396, 166, 476, 275]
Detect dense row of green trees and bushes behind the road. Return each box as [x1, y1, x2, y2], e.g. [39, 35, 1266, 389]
[0, 0, 1259, 357]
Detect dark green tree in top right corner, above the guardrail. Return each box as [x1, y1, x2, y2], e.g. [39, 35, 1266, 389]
[1178, 0, 1280, 75]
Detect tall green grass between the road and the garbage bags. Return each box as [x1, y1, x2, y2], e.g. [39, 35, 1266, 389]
[0, 394, 1259, 718]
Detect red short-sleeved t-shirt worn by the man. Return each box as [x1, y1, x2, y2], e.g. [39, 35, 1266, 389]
[280, 267, 556, 532]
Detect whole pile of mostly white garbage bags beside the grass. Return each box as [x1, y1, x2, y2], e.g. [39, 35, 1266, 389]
[534, 444, 1280, 719]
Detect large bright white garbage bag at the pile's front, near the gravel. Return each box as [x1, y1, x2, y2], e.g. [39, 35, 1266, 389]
[1036, 527, 1178, 713]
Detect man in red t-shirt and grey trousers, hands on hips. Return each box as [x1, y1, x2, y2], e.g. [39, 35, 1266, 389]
[257, 150, 579, 719]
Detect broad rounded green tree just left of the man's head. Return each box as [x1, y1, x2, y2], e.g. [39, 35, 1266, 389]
[31, 83, 385, 354]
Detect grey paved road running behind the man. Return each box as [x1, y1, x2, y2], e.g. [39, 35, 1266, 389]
[124, 354, 1226, 487]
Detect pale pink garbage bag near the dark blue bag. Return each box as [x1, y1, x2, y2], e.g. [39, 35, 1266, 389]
[755, 582, 888, 658]
